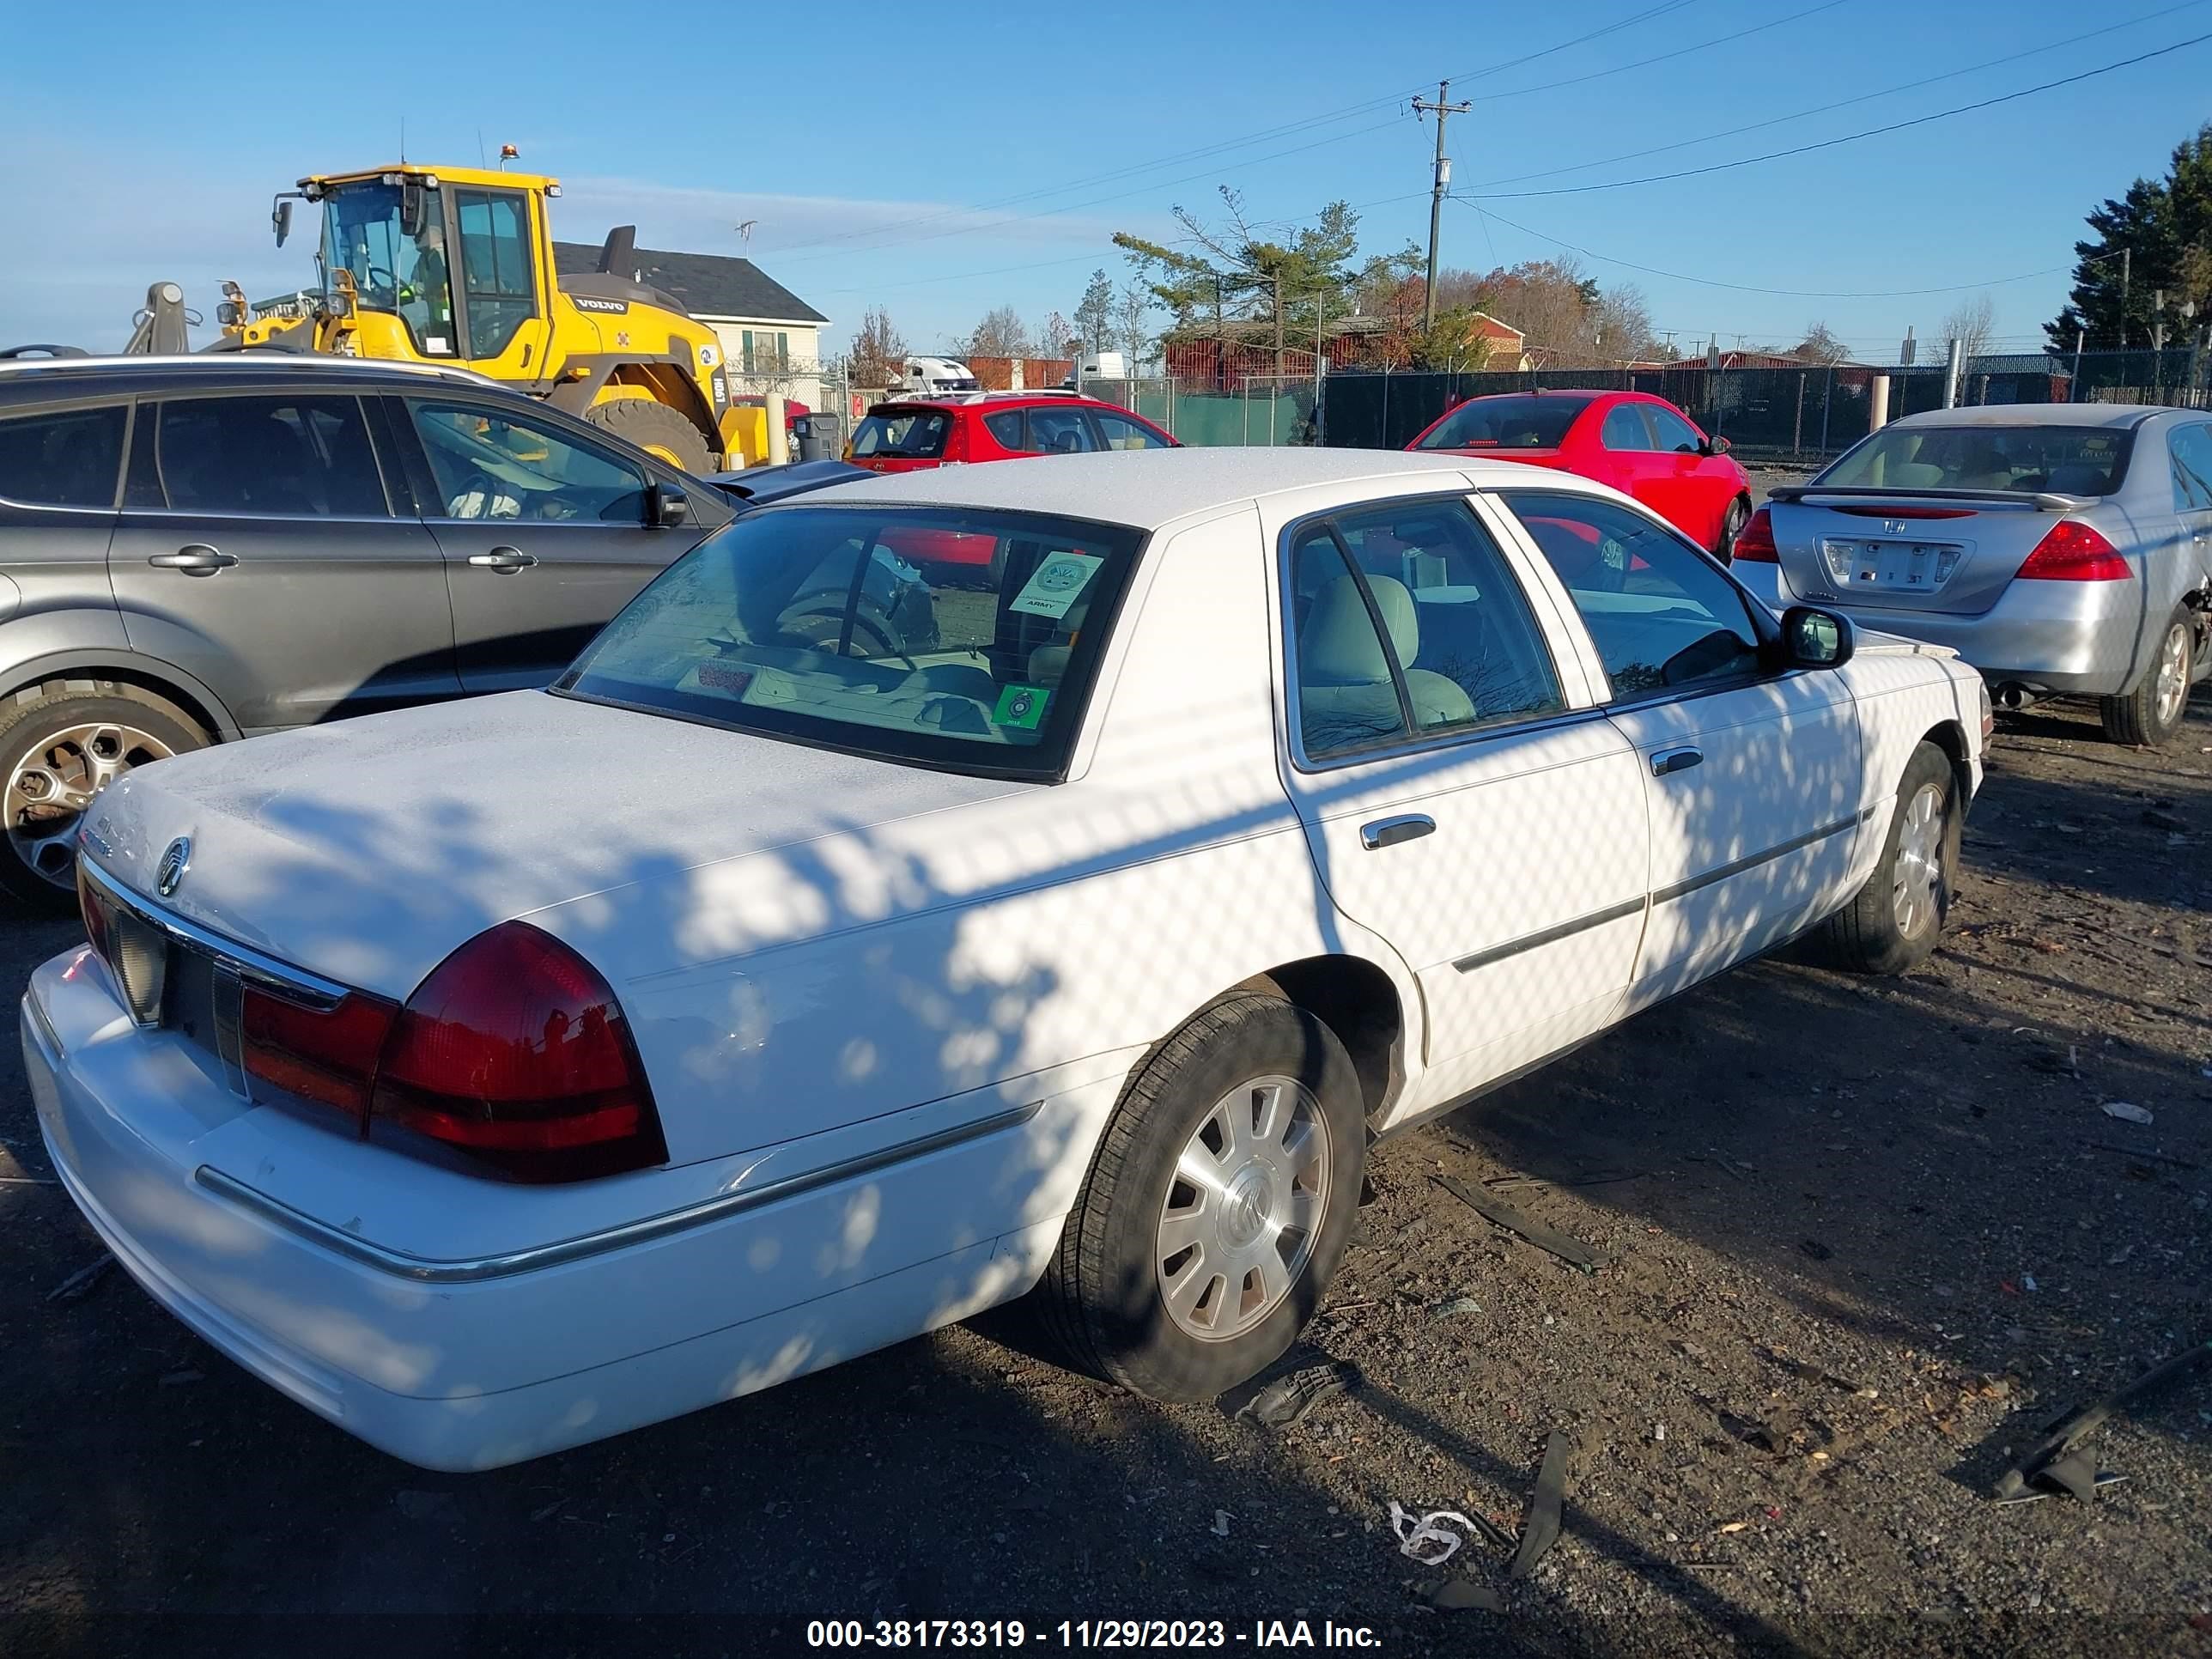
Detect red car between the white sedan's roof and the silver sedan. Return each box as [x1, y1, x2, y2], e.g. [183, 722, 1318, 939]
[1407, 392, 1752, 560]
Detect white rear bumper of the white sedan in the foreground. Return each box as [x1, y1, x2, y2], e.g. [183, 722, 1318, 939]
[20, 956, 1113, 1468]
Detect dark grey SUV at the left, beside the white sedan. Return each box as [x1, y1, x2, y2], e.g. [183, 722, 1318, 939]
[0, 354, 734, 902]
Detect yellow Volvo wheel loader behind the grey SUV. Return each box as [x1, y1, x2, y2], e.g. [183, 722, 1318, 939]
[215, 164, 763, 473]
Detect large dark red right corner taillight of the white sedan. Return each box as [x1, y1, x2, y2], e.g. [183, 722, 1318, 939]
[369, 922, 668, 1182]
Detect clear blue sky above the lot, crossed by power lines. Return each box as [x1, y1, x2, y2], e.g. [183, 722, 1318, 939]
[0, 0, 2212, 361]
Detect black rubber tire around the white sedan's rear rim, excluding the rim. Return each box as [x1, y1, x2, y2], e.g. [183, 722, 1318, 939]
[1037, 994, 1367, 1401]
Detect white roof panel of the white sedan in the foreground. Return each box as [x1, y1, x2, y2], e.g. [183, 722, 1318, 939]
[801, 447, 1565, 531]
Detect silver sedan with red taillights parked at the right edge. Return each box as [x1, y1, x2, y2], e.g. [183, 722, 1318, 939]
[1736, 403, 2212, 745]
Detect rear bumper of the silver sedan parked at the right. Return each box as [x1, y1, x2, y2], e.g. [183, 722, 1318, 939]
[1732, 562, 2143, 696]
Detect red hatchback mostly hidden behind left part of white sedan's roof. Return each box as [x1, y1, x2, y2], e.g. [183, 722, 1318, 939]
[845, 392, 1176, 473]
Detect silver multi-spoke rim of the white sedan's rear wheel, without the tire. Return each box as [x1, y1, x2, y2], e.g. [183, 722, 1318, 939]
[1152, 1078, 1329, 1343]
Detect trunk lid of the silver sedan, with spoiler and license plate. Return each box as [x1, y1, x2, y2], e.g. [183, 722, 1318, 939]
[1770, 484, 2132, 615]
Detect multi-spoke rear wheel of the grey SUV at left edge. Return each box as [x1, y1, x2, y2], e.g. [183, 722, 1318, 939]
[0, 679, 215, 914]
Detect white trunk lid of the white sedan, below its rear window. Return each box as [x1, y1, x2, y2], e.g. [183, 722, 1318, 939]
[86, 692, 1026, 1000]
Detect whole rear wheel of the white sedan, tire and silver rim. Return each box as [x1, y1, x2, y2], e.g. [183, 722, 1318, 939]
[1037, 994, 1367, 1401]
